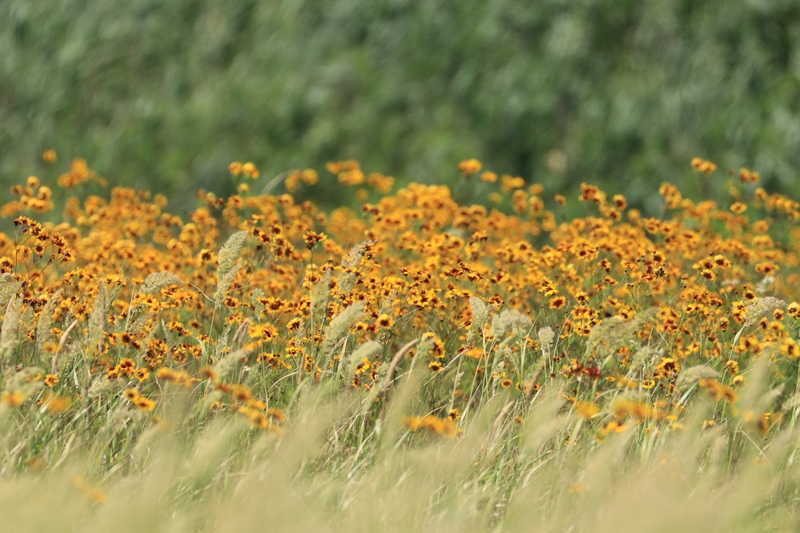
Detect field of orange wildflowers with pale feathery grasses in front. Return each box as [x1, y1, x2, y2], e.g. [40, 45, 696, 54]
[0, 156, 800, 533]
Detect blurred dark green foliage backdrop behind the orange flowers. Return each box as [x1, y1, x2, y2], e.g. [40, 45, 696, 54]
[0, 0, 800, 214]
